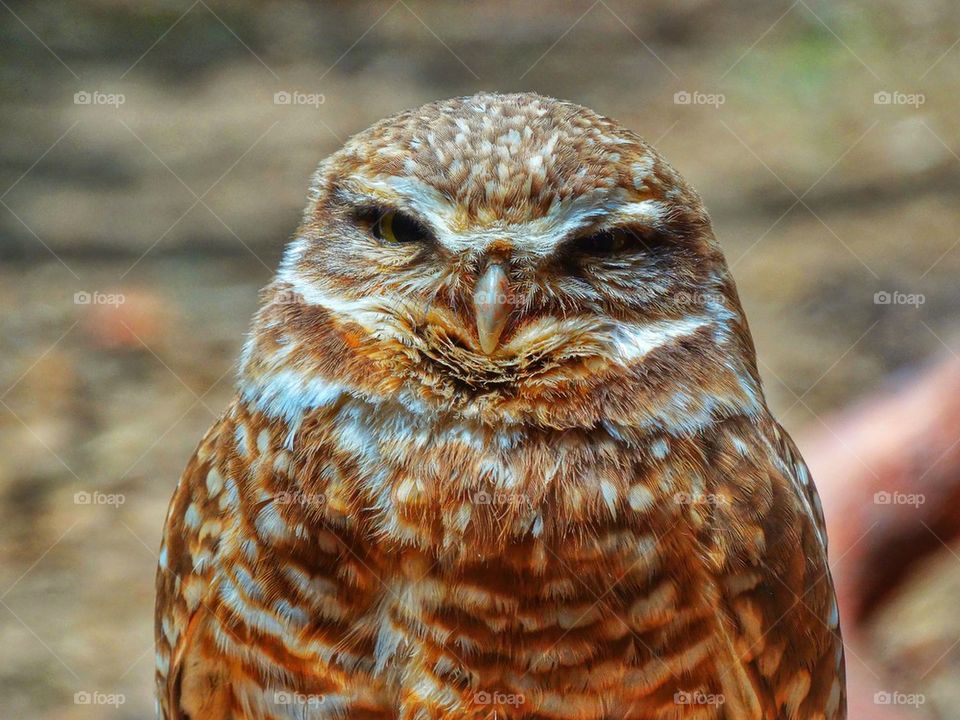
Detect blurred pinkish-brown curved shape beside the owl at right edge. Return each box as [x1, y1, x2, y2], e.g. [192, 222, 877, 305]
[798, 357, 960, 720]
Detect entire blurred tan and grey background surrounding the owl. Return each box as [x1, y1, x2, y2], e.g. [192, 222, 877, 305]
[0, 0, 960, 720]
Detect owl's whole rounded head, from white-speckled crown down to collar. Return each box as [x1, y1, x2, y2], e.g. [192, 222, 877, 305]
[241, 94, 762, 432]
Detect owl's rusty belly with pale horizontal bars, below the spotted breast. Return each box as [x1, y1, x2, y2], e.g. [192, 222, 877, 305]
[218, 524, 728, 720]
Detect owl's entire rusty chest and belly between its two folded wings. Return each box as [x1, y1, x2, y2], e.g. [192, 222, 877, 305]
[232, 414, 728, 717]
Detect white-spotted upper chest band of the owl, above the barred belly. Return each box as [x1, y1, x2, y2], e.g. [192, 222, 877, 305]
[316, 415, 704, 556]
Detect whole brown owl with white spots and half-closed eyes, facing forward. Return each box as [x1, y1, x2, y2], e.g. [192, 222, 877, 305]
[156, 94, 846, 720]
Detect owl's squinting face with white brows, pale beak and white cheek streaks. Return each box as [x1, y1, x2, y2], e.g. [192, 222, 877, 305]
[281, 173, 728, 392]
